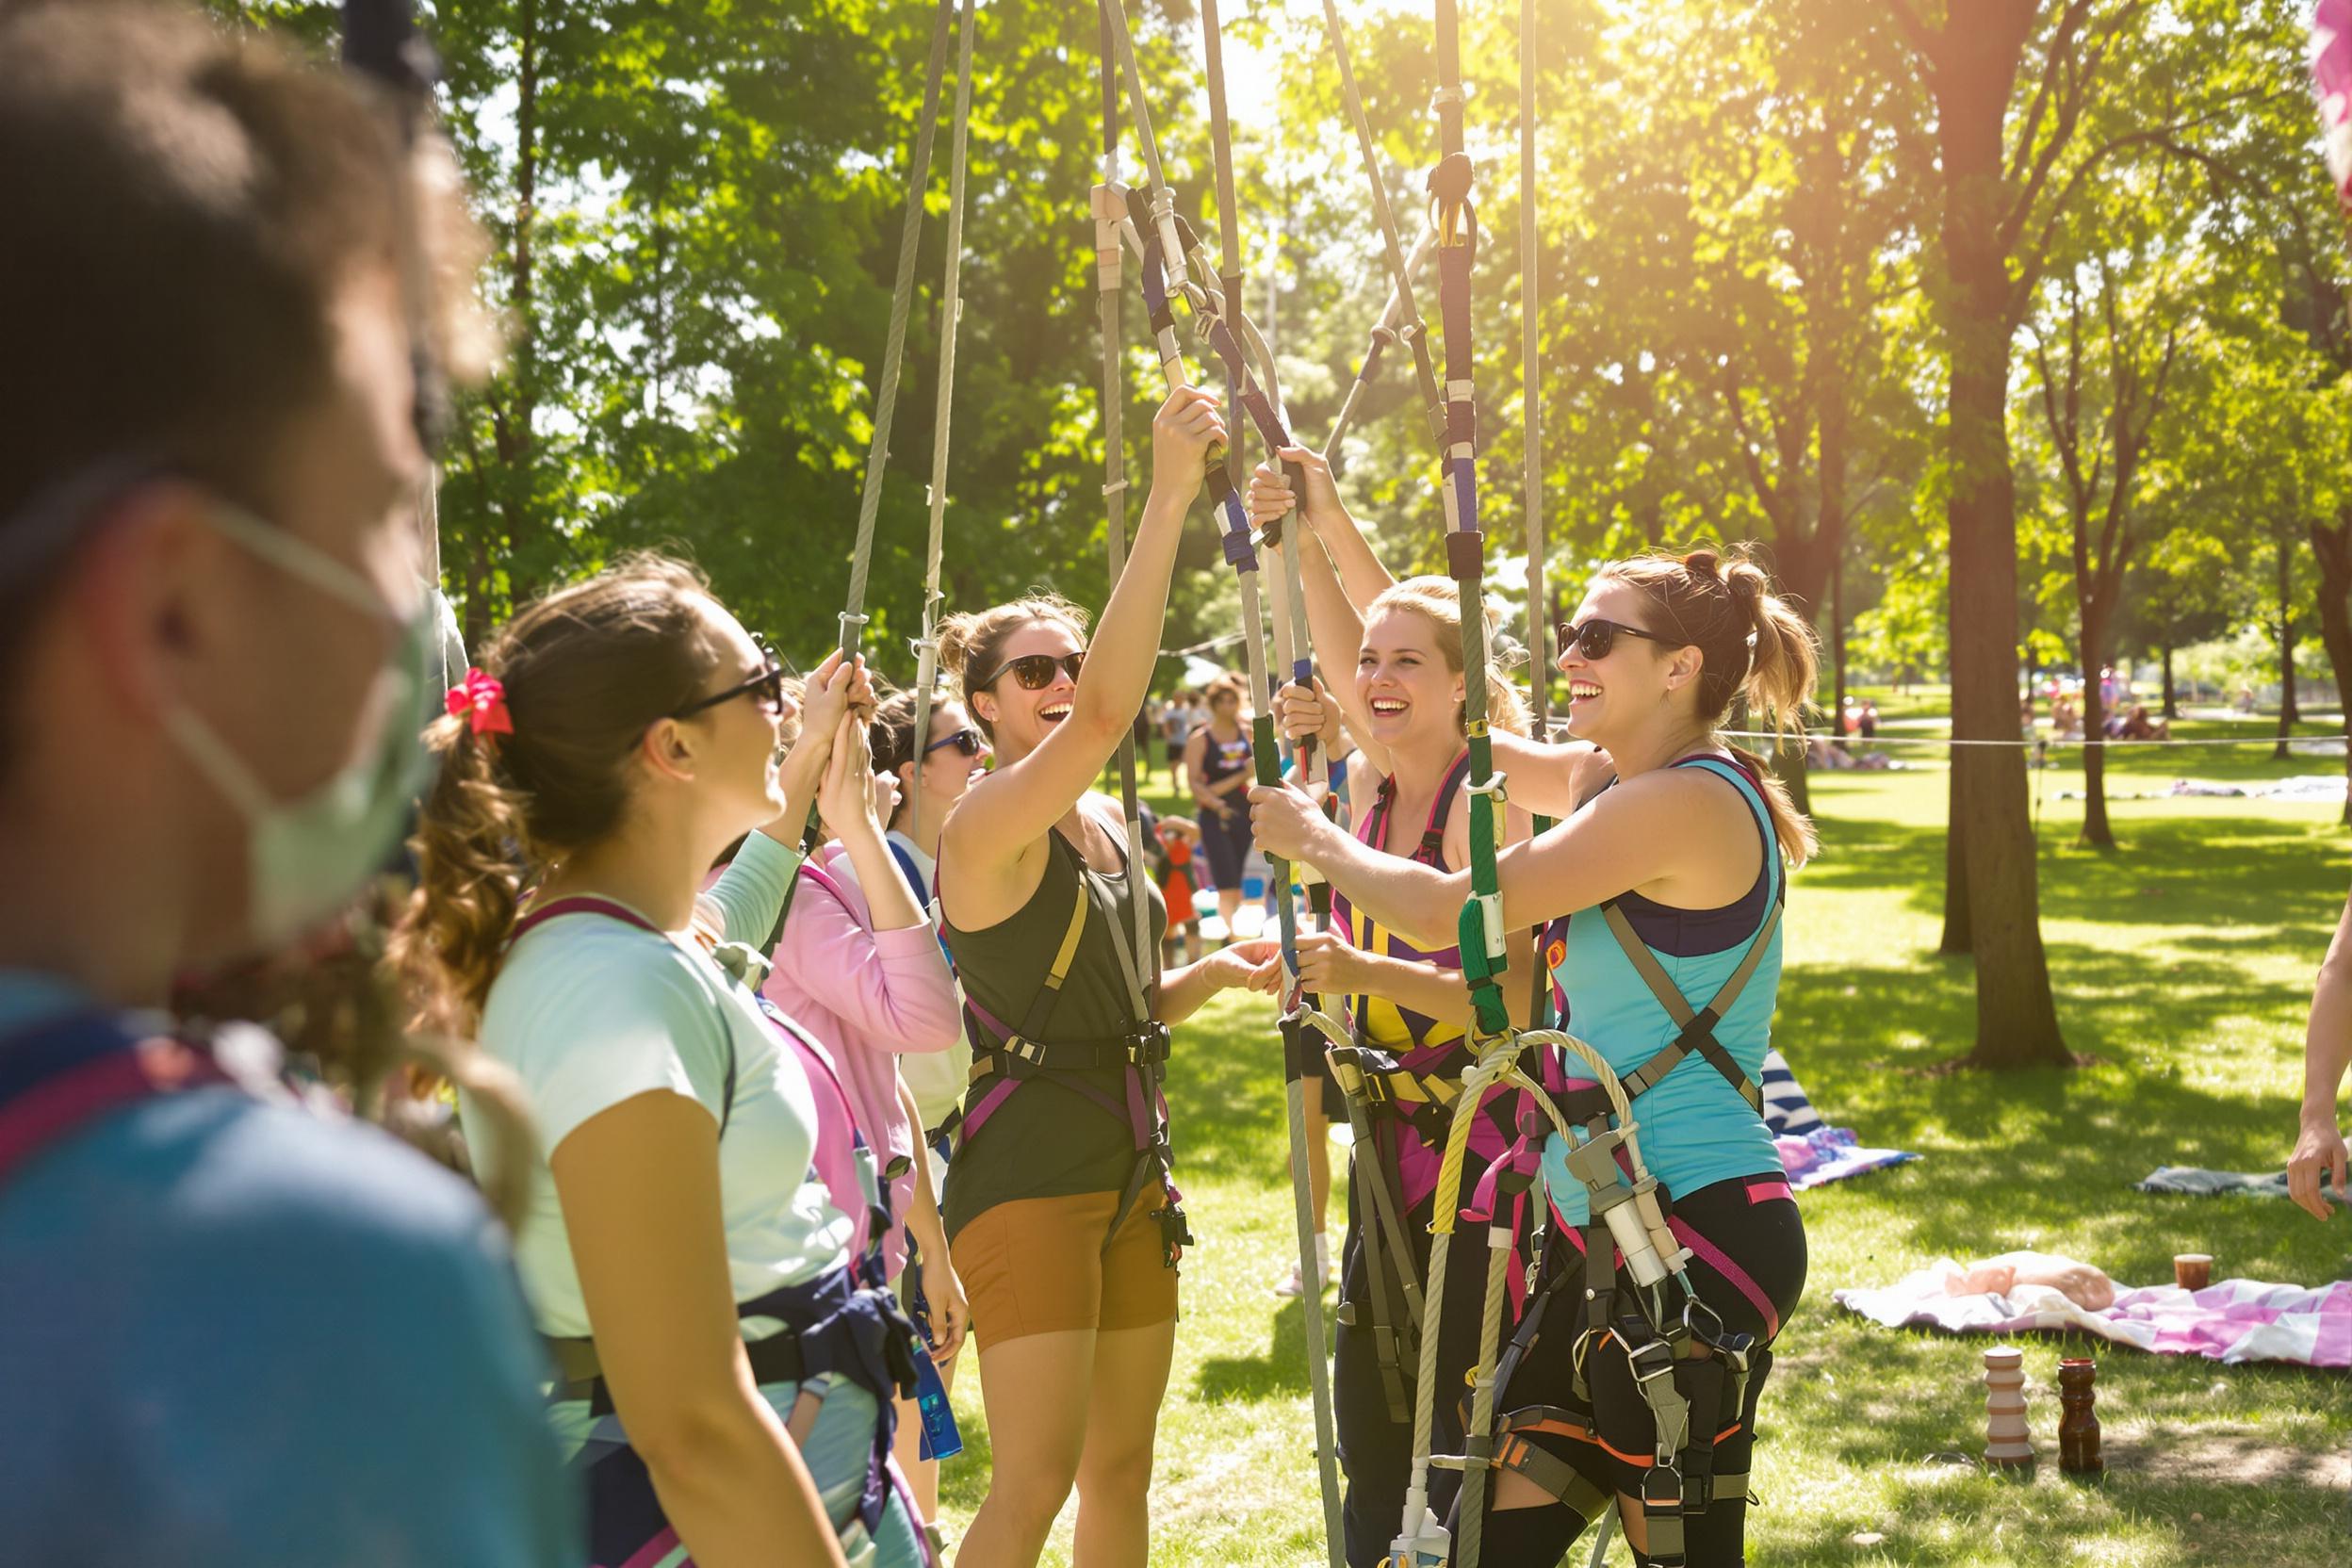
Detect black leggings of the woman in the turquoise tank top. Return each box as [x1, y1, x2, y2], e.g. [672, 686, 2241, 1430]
[1481, 1175, 1806, 1568]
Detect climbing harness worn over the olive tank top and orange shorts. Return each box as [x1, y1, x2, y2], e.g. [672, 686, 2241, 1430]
[957, 832, 1192, 1269]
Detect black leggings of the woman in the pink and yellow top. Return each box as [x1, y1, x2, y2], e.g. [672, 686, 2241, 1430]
[1331, 1133, 1543, 1568]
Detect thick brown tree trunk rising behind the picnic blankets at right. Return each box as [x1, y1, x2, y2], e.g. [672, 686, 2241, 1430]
[1936, 24, 2072, 1068]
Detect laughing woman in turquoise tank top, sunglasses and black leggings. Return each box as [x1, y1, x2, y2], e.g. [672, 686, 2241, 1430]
[1251, 550, 1816, 1566]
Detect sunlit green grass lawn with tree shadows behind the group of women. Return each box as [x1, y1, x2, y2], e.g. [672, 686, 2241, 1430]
[926, 752, 2352, 1568]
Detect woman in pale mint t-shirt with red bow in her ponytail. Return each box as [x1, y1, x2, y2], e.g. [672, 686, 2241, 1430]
[393, 557, 924, 1568]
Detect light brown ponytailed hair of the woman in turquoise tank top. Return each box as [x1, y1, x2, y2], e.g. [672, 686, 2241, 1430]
[1599, 546, 1821, 865]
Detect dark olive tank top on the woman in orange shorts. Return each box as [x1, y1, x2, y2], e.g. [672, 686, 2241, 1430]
[940, 825, 1167, 1239]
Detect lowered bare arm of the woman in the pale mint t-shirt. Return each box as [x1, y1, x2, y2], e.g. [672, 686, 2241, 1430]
[548, 1091, 842, 1568]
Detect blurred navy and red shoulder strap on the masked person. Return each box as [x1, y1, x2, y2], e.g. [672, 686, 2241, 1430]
[0, 1013, 231, 1187]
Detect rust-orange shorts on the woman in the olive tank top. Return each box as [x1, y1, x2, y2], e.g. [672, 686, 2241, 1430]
[950, 1184, 1176, 1349]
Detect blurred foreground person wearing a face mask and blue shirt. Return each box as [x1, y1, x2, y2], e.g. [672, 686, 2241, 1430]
[0, 5, 581, 1568]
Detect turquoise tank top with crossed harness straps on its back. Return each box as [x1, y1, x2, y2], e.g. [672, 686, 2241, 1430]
[1543, 755, 1788, 1225]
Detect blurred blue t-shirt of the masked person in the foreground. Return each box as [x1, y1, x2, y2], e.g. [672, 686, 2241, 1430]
[0, 975, 586, 1568]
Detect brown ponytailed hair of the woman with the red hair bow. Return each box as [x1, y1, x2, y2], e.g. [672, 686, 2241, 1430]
[390, 555, 720, 1037]
